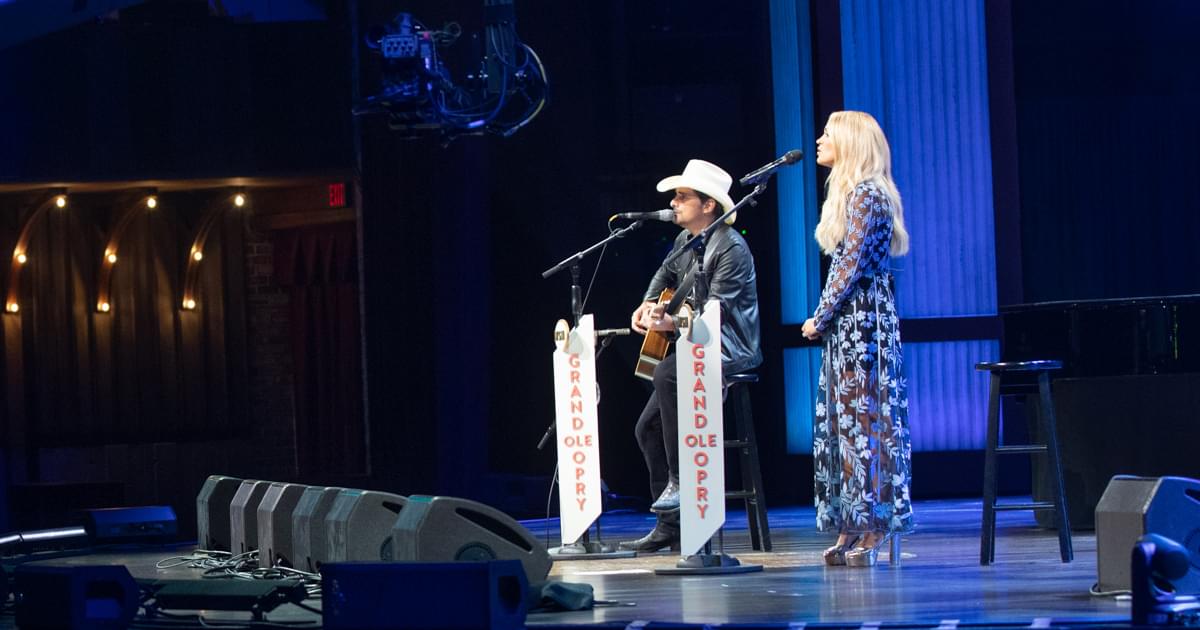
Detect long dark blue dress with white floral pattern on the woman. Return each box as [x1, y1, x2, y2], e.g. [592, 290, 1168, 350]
[812, 182, 912, 533]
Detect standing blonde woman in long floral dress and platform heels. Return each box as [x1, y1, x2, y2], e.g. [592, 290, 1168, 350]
[803, 112, 912, 566]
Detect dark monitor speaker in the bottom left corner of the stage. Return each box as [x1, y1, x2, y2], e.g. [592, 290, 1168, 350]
[13, 564, 138, 630]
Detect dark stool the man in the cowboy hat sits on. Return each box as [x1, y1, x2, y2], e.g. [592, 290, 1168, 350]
[725, 372, 770, 551]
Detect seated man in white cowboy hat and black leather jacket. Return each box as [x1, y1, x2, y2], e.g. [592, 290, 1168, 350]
[619, 160, 762, 552]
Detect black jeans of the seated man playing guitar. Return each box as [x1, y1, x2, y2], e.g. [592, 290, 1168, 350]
[634, 353, 679, 499]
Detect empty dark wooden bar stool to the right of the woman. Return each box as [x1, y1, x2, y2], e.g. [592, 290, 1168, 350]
[976, 361, 1075, 565]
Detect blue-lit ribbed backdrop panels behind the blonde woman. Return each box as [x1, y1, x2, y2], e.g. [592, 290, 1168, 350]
[772, 0, 998, 454]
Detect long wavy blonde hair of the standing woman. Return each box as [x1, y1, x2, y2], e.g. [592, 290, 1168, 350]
[816, 112, 908, 256]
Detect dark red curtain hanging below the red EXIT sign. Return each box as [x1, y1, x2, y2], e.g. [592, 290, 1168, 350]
[275, 223, 367, 476]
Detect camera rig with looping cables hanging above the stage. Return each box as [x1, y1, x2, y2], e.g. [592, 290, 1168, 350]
[354, 0, 547, 144]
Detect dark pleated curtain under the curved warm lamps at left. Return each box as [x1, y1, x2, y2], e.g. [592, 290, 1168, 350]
[6, 196, 247, 448]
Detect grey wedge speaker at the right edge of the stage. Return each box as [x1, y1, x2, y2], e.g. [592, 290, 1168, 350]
[1096, 475, 1200, 595]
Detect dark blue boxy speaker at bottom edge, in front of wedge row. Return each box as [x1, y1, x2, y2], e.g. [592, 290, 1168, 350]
[320, 560, 527, 630]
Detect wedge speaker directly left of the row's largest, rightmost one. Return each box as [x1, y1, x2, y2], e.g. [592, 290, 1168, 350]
[325, 490, 408, 562]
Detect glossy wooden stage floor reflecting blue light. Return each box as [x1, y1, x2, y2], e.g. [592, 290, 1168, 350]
[0, 499, 1129, 629]
